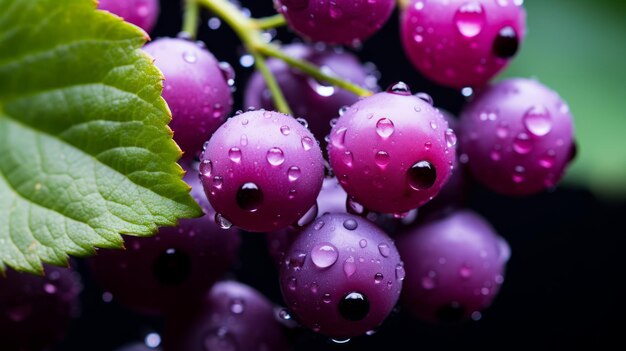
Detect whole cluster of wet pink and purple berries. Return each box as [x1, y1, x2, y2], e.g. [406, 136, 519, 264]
[0, 0, 576, 350]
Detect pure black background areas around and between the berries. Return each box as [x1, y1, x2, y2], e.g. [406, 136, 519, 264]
[54, 0, 626, 351]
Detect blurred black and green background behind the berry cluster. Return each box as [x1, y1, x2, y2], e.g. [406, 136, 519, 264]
[53, 0, 626, 351]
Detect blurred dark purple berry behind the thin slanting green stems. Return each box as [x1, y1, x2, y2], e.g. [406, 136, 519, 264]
[244, 44, 377, 153]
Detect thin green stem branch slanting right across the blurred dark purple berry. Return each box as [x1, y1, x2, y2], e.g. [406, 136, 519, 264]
[258, 44, 373, 96]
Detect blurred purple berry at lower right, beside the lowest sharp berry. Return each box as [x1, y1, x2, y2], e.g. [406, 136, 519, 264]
[398, 211, 510, 322]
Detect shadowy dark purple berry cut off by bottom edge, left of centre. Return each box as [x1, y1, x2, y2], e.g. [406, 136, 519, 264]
[165, 281, 289, 351]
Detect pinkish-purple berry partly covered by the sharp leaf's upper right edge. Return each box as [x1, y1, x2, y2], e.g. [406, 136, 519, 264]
[144, 38, 233, 158]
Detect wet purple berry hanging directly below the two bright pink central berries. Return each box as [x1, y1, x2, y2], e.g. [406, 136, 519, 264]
[280, 214, 404, 338]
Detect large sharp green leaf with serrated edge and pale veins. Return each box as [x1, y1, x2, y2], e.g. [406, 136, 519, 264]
[0, 0, 201, 273]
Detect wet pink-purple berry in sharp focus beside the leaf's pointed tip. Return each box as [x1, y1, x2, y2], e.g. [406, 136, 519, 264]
[200, 110, 324, 232]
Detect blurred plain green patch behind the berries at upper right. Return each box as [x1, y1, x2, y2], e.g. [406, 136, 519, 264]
[498, 0, 626, 199]
